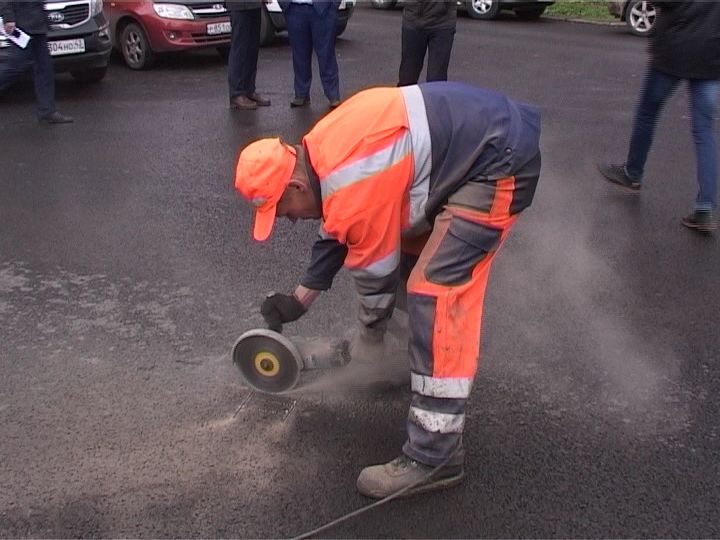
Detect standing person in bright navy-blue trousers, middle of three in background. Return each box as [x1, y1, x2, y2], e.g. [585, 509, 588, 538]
[280, 0, 340, 109]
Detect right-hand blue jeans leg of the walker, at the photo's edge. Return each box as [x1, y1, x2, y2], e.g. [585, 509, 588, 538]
[690, 79, 720, 210]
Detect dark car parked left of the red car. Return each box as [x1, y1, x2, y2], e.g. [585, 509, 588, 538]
[0, 0, 112, 82]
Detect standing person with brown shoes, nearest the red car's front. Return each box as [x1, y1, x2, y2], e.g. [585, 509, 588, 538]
[225, 0, 270, 110]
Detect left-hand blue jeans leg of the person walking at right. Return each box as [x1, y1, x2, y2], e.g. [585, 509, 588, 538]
[625, 68, 680, 180]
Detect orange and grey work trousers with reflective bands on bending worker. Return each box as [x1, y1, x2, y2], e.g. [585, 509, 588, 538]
[403, 154, 540, 466]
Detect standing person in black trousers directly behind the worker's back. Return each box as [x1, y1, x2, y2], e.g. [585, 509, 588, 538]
[398, 0, 457, 86]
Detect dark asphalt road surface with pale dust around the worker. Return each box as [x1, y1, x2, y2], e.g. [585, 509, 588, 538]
[0, 7, 720, 538]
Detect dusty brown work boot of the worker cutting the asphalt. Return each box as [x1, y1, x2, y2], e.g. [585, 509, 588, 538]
[357, 454, 465, 499]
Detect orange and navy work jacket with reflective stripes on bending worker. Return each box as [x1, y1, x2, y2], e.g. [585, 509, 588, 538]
[301, 82, 540, 326]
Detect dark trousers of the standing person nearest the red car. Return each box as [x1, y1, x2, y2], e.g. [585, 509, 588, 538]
[228, 8, 262, 99]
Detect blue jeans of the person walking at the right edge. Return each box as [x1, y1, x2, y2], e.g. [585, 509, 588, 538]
[625, 68, 720, 210]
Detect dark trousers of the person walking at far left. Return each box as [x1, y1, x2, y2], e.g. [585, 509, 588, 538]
[0, 34, 55, 117]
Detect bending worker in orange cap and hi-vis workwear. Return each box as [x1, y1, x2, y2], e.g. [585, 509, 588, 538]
[235, 82, 540, 498]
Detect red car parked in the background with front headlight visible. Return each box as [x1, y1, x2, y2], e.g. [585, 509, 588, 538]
[105, 0, 230, 69]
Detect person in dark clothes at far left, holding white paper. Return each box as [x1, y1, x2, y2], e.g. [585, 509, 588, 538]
[0, 0, 73, 124]
